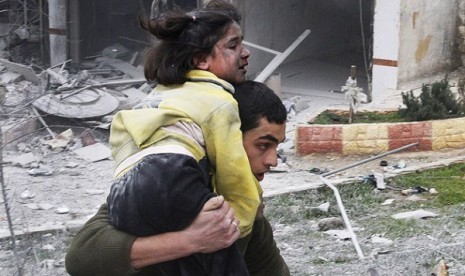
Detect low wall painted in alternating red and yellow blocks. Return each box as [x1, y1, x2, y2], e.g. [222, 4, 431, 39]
[295, 118, 465, 155]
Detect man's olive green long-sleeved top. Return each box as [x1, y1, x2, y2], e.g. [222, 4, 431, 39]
[66, 204, 290, 276]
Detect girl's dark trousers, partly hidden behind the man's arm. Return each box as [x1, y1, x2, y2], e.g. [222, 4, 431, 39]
[107, 153, 249, 276]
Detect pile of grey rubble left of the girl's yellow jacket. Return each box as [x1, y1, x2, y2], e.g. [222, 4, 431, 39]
[0, 52, 153, 151]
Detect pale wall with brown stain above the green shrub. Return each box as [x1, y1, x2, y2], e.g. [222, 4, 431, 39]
[398, 0, 456, 86]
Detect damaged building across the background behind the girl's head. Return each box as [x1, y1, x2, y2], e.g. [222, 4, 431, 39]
[1, 0, 465, 112]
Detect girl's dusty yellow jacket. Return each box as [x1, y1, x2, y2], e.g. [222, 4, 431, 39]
[110, 70, 262, 237]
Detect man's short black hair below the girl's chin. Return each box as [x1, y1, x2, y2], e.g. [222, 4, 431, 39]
[234, 80, 287, 133]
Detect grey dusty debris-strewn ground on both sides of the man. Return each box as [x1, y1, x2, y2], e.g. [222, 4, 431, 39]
[0, 122, 465, 275]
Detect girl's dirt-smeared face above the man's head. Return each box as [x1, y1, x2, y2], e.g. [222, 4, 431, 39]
[205, 23, 250, 84]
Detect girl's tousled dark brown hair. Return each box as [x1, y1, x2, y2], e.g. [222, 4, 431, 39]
[140, 0, 241, 85]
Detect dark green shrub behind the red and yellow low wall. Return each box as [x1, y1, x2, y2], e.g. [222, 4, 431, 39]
[399, 78, 465, 121]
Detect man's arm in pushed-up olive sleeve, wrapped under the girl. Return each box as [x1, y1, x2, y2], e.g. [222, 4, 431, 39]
[66, 196, 239, 276]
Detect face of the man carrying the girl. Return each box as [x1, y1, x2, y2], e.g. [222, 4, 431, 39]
[242, 118, 286, 181]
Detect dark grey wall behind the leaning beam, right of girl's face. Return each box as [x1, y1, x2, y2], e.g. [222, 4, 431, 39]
[241, 0, 373, 75]
